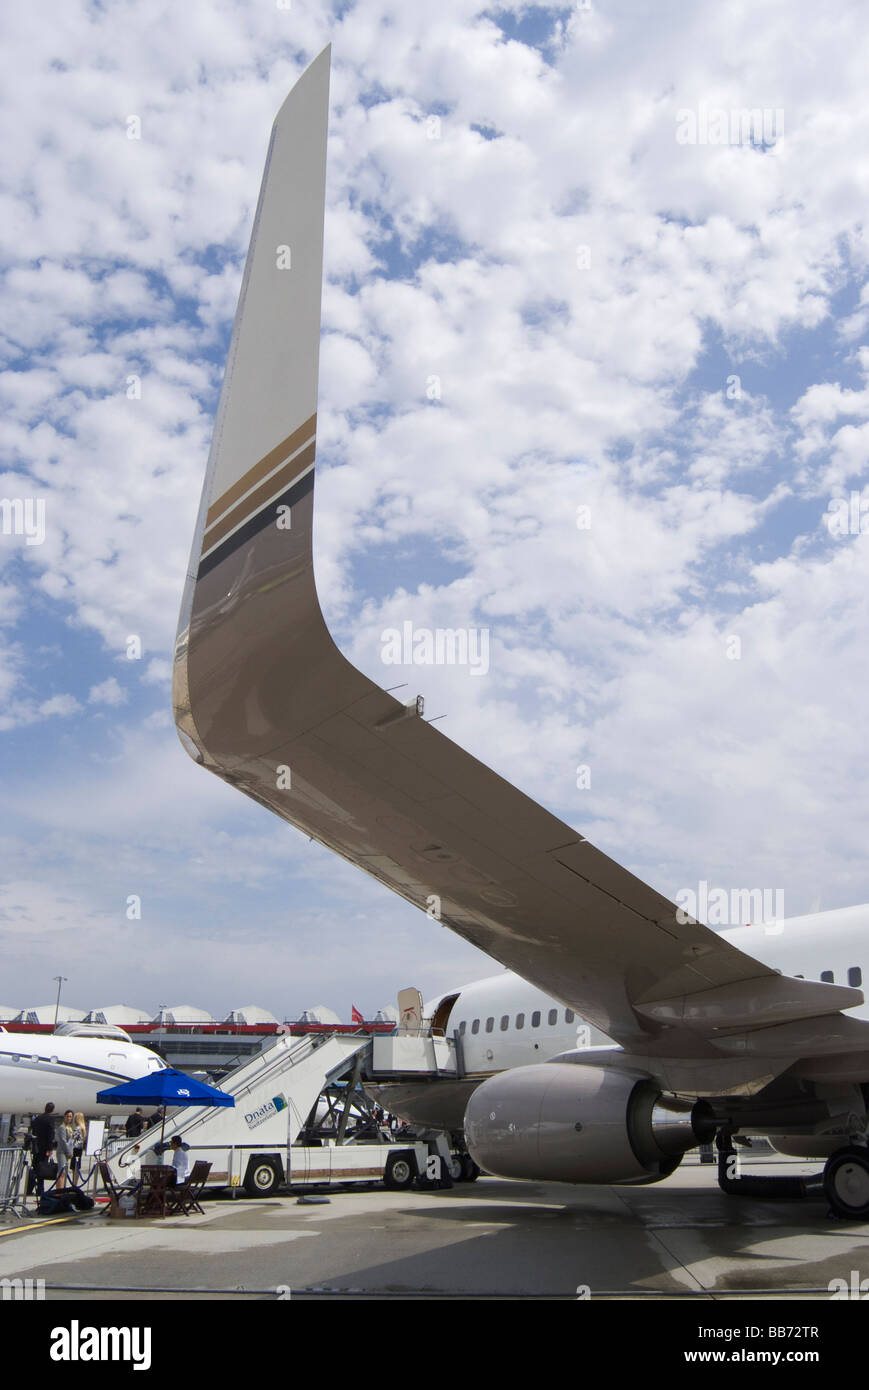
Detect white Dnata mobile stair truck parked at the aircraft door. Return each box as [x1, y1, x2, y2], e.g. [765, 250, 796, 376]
[108, 1033, 436, 1197]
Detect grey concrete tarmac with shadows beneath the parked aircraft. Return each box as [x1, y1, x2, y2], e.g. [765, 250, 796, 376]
[0, 1158, 869, 1302]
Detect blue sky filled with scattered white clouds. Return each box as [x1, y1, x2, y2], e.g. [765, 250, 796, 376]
[0, 0, 869, 1017]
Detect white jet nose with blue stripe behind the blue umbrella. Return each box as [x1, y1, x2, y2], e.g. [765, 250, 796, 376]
[0, 1023, 165, 1119]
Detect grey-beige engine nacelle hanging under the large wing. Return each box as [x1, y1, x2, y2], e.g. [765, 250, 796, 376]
[464, 1062, 700, 1183]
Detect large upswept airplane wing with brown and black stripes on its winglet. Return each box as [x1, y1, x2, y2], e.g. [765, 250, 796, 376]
[174, 49, 869, 1074]
